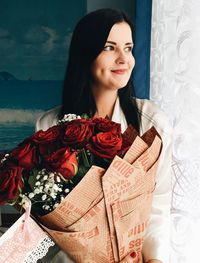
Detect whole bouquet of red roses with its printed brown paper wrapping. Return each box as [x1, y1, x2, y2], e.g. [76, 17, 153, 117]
[0, 114, 162, 262]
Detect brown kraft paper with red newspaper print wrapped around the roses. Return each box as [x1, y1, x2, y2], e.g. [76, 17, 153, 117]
[40, 127, 162, 263]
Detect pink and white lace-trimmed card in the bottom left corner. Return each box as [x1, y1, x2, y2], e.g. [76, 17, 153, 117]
[0, 210, 55, 263]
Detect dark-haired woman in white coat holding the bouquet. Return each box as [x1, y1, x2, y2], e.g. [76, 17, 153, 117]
[36, 9, 172, 263]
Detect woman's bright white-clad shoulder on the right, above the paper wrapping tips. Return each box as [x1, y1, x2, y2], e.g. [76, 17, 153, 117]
[135, 98, 172, 135]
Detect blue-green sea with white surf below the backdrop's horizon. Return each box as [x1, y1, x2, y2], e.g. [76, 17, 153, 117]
[0, 76, 63, 151]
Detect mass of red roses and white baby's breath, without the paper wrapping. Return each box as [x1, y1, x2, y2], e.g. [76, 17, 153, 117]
[0, 114, 131, 215]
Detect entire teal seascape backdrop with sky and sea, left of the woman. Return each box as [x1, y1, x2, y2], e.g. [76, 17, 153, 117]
[0, 0, 87, 152]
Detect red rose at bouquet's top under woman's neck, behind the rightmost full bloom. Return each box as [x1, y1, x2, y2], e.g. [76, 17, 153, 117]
[93, 118, 121, 134]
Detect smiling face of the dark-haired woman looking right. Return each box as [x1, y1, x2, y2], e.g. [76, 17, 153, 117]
[92, 22, 135, 93]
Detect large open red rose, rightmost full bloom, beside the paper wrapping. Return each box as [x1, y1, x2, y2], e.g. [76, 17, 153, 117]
[87, 132, 122, 159]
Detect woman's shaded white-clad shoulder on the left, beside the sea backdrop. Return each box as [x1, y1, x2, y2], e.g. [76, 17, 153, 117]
[36, 106, 61, 131]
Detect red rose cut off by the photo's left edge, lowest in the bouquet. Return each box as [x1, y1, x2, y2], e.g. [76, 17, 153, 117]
[0, 166, 23, 205]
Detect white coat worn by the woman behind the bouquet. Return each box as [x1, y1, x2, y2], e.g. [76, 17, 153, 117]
[36, 99, 172, 263]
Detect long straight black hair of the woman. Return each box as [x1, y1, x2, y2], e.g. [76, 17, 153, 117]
[59, 9, 139, 131]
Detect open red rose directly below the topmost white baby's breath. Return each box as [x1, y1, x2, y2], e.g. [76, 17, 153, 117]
[63, 119, 94, 148]
